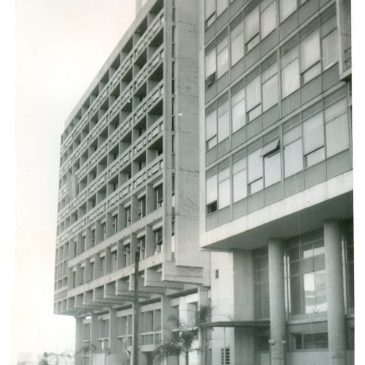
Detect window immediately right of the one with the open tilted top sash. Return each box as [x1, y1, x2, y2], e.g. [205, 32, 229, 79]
[283, 126, 303, 177]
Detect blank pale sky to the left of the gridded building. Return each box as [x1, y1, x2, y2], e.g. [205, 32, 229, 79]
[11, 0, 135, 362]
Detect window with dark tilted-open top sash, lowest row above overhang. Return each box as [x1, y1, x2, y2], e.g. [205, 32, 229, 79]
[262, 140, 281, 187]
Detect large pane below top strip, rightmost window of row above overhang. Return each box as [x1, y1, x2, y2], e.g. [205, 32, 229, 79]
[326, 114, 350, 157]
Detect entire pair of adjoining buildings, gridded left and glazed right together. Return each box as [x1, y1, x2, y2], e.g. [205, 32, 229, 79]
[55, 0, 354, 365]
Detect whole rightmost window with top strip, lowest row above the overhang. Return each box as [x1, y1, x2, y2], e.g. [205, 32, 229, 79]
[324, 99, 350, 157]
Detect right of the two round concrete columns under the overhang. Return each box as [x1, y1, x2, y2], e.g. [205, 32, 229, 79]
[324, 220, 346, 365]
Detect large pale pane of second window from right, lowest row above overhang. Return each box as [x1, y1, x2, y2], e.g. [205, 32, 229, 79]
[303, 113, 324, 155]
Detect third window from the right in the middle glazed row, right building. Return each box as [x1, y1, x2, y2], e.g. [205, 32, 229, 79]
[281, 47, 300, 98]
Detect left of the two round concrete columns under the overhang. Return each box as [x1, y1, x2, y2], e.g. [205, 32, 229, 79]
[268, 239, 286, 365]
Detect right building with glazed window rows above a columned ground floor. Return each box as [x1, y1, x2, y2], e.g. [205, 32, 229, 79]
[200, 0, 354, 365]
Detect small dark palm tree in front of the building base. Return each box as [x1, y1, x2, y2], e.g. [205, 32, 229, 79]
[155, 306, 211, 365]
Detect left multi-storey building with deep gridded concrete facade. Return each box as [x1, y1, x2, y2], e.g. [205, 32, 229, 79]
[55, 0, 209, 365]
